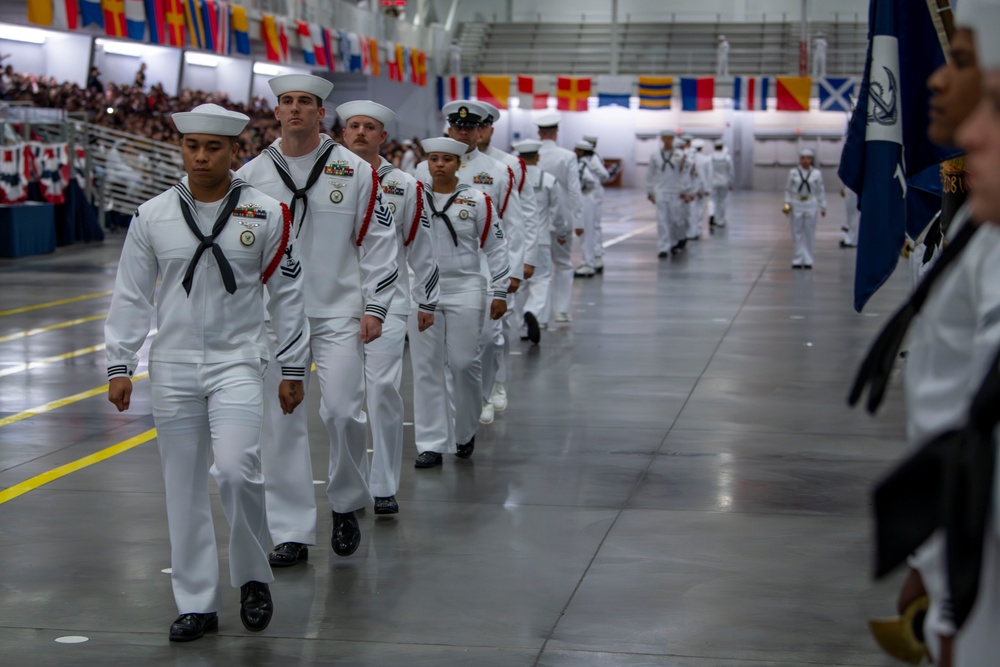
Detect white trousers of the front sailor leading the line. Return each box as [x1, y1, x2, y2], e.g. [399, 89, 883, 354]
[149, 359, 277, 614]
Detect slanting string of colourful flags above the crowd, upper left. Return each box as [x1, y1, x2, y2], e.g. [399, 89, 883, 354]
[26, 0, 427, 86]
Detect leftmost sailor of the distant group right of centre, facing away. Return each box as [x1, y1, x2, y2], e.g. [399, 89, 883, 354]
[646, 129, 691, 259]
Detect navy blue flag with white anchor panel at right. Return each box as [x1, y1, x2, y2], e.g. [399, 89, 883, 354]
[838, 0, 959, 312]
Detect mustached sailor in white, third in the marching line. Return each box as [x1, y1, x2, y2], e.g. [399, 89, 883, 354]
[337, 100, 439, 514]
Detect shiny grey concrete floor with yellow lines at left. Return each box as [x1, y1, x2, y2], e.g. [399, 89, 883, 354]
[0, 190, 907, 667]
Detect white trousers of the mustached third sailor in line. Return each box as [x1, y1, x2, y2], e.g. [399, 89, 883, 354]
[364, 313, 406, 498]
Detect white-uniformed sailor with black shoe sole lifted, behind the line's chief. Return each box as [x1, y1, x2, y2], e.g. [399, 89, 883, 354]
[513, 139, 573, 345]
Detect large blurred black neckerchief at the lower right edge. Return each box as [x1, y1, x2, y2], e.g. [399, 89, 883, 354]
[874, 344, 1000, 630]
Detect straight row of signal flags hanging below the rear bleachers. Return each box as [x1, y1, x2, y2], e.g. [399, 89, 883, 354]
[437, 75, 855, 112]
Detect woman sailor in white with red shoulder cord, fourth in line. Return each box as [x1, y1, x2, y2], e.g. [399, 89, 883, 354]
[409, 136, 510, 468]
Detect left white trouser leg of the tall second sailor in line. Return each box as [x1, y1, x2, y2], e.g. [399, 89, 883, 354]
[261, 321, 316, 545]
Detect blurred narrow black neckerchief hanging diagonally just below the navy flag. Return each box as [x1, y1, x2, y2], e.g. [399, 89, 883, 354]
[847, 220, 979, 414]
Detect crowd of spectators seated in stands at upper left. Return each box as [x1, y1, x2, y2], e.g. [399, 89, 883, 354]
[0, 65, 423, 169]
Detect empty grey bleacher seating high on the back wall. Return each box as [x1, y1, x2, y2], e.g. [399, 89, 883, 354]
[462, 21, 868, 76]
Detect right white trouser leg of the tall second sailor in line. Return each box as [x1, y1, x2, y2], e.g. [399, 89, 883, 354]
[309, 317, 371, 514]
